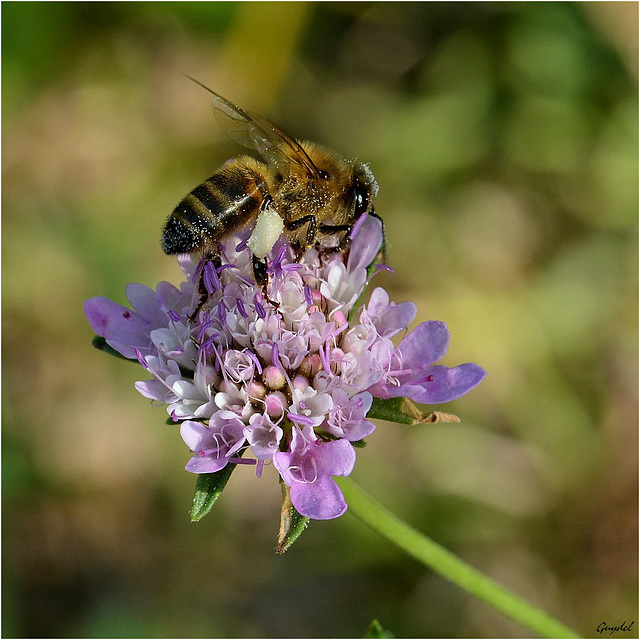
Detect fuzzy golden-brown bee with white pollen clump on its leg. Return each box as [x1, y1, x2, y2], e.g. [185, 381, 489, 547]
[162, 78, 380, 317]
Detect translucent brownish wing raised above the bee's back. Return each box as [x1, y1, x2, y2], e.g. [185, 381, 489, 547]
[211, 91, 319, 177]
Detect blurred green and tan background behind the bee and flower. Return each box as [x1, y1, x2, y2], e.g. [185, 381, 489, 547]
[2, 2, 638, 637]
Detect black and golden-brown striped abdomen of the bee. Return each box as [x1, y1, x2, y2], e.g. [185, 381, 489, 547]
[162, 160, 267, 254]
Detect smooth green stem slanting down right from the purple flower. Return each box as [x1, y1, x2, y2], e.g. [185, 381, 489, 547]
[335, 477, 579, 638]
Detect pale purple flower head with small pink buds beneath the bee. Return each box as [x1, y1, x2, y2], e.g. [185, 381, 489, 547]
[84, 217, 485, 520]
